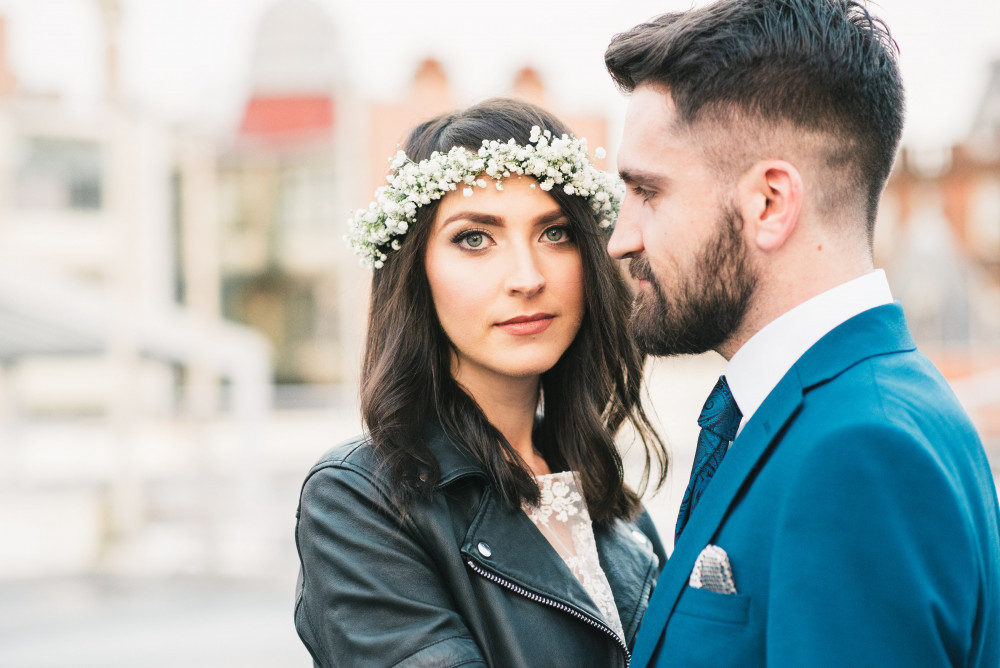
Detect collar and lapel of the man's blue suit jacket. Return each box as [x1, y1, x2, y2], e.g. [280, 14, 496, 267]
[633, 304, 916, 666]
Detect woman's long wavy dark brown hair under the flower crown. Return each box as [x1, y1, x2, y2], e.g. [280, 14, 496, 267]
[361, 99, 667, 523]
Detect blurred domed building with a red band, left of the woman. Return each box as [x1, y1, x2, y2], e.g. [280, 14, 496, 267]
[218, 0, 364, 384]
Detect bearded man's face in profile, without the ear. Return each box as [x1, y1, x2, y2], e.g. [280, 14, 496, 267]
[608, 86, 757, 355]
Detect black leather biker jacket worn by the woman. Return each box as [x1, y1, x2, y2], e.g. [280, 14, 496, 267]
[295, 430, 666, 668]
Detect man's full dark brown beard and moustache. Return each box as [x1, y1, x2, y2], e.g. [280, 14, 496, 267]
[629, 207, 757, 356]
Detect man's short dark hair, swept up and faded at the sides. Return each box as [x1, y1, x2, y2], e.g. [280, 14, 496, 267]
[604, 0, 903, 242]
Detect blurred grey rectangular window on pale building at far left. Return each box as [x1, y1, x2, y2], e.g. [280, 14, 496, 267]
[14, 137, 102, 211]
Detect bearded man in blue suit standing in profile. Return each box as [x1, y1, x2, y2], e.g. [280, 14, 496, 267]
[605, 0, 1000, 667]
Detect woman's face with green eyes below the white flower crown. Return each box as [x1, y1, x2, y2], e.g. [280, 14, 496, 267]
[424, 177, 584, 389]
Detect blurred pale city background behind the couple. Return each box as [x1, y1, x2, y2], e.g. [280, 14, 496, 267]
[0, 0, 1000, 667]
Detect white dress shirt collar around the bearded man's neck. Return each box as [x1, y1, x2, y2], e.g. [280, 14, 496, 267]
[726, 269, 892, 430]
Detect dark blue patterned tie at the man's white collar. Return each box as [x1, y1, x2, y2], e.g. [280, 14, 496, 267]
[674, 376, 743, 542]
